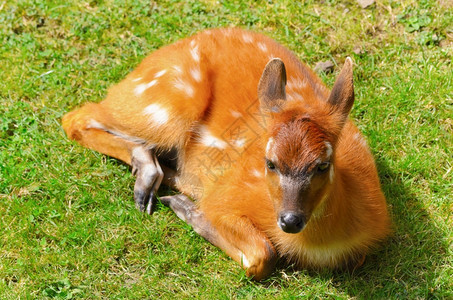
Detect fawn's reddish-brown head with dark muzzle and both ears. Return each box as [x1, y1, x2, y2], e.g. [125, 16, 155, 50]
[258, 58, 354, 233]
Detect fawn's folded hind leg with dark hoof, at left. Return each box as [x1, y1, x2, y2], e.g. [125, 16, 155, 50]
[62, 104, 174, 214]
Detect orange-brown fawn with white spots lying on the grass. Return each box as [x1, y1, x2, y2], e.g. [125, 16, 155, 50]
[62, 28, 390, 280]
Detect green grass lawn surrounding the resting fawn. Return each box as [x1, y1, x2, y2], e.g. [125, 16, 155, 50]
[0, 0, 453, 299]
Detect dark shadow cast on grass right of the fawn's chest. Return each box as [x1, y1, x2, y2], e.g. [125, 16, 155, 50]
[268, 156, 453, 299]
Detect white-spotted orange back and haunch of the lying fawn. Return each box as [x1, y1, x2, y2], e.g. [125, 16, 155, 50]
[78, 28, 328, 198]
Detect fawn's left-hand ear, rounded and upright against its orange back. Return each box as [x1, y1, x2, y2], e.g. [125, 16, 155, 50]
[258, 58, 286, 112]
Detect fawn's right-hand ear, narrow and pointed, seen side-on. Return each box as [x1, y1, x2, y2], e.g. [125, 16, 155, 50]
[328, 57, 354, 121]
